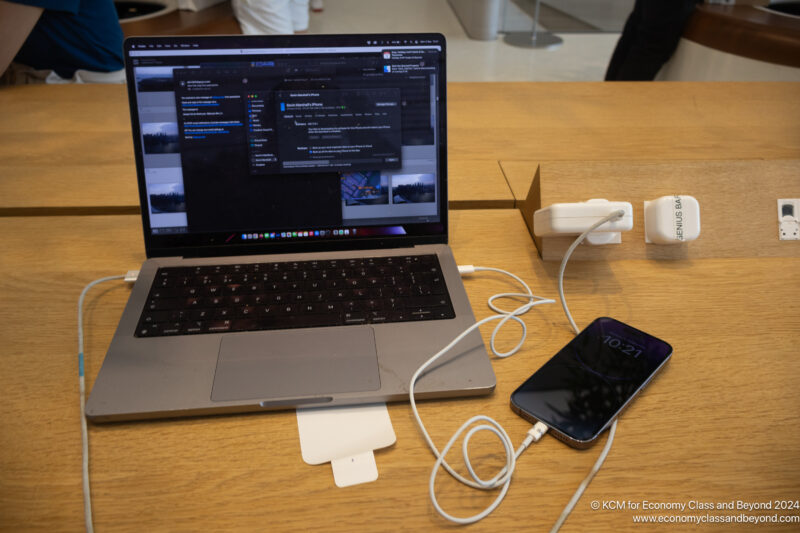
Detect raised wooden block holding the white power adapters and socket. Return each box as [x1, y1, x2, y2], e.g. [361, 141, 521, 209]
[518, 160, 800, 261]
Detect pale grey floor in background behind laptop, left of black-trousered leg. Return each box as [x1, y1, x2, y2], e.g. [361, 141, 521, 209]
[309, 0, 619, 81]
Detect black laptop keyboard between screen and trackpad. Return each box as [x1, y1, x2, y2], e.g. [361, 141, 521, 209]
[135, 255, 455, 337]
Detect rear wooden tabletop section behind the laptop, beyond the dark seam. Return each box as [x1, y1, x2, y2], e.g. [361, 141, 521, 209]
[0, 82, 800, 216]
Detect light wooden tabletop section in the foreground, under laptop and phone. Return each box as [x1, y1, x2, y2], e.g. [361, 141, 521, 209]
[0, 209, 800, 532]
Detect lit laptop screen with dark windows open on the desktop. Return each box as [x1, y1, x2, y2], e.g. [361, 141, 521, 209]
[125, 34, 447, 256]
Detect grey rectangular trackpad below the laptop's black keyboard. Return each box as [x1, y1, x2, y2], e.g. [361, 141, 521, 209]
[211, 326, 381, 401]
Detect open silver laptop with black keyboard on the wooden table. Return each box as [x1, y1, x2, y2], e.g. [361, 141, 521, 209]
[86, 34, 495, 421]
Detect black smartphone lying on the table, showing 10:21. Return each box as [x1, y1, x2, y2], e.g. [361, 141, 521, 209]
[511, 317, 672, 442]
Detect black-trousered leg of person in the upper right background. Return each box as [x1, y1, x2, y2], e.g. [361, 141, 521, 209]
[606, 0, 701, 81]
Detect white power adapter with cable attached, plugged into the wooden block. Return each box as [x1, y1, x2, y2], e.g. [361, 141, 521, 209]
[533, 198, 633, 244]
